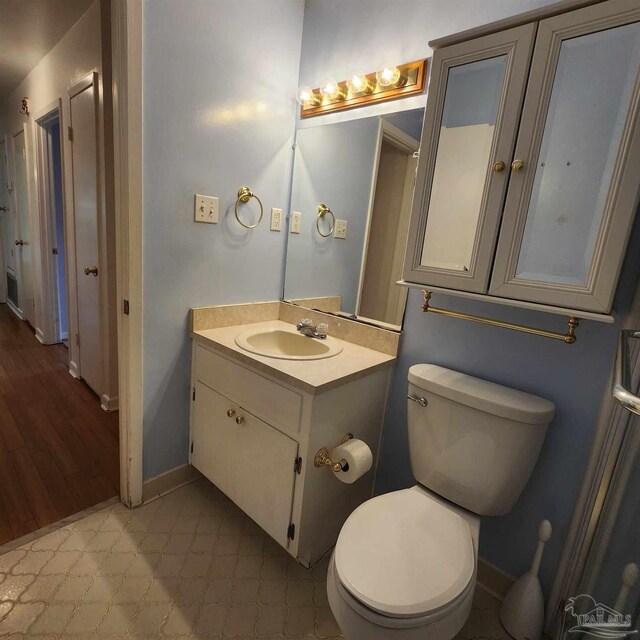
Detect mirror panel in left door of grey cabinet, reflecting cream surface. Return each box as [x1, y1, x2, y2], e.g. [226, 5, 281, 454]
[421, 55, 507, 271]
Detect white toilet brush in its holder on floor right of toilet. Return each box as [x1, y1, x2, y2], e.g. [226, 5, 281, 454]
[500, 520, 551, 640]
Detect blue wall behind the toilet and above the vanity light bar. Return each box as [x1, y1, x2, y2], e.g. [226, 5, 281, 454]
[300, 0, 640, 595]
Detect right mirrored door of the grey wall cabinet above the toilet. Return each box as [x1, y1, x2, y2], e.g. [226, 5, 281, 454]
[490, 0, 640, 313]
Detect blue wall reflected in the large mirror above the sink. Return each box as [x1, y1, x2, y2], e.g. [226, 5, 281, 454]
[284, 117, 380, 313]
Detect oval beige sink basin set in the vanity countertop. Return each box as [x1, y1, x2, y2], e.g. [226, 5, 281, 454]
[236, 329, 342, 360]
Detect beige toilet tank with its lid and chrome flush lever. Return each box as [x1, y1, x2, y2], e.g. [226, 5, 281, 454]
[407, 364, 555, 516]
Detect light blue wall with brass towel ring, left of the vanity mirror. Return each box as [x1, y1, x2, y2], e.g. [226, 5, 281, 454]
[143, 0, 304, 478]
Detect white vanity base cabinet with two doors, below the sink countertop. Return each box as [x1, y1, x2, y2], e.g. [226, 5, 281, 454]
[190, 339, 391, 566]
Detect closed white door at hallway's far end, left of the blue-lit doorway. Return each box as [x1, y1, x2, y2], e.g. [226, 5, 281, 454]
[13, 129, 35, 326]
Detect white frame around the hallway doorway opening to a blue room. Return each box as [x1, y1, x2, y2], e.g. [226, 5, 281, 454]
[33, 98, 72, 344]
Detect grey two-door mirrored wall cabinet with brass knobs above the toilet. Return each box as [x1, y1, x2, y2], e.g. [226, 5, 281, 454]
[404, 0, 640, 314]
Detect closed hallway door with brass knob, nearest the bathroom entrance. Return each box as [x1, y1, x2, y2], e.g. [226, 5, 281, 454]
[70, 77, 103, 394]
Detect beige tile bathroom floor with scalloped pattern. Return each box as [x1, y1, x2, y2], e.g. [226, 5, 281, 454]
[0, 480, 507, 640]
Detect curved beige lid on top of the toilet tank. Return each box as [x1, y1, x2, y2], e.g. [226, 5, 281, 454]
[409, 364, 555, 425]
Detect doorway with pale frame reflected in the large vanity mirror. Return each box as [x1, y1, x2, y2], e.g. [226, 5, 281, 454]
[356, 121, 419, 326]
